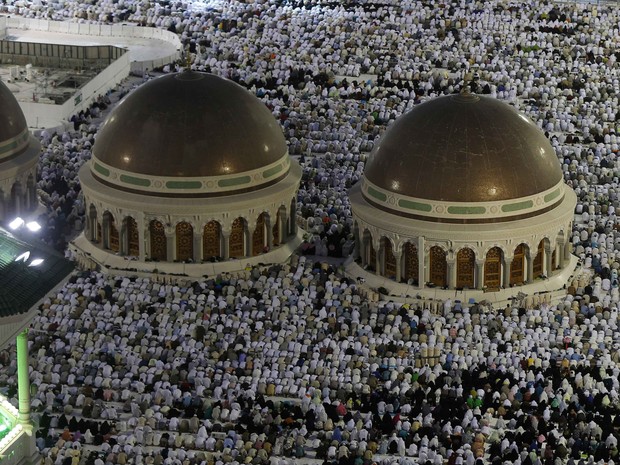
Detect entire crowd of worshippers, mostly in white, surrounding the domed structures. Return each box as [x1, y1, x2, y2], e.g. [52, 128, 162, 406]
[0, 0, 620, 465]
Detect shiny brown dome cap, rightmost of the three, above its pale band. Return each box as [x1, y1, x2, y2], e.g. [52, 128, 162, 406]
[364, 93, 562, 202]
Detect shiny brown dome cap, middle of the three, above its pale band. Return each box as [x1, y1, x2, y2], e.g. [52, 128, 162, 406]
[93, 71, 287, 178]
